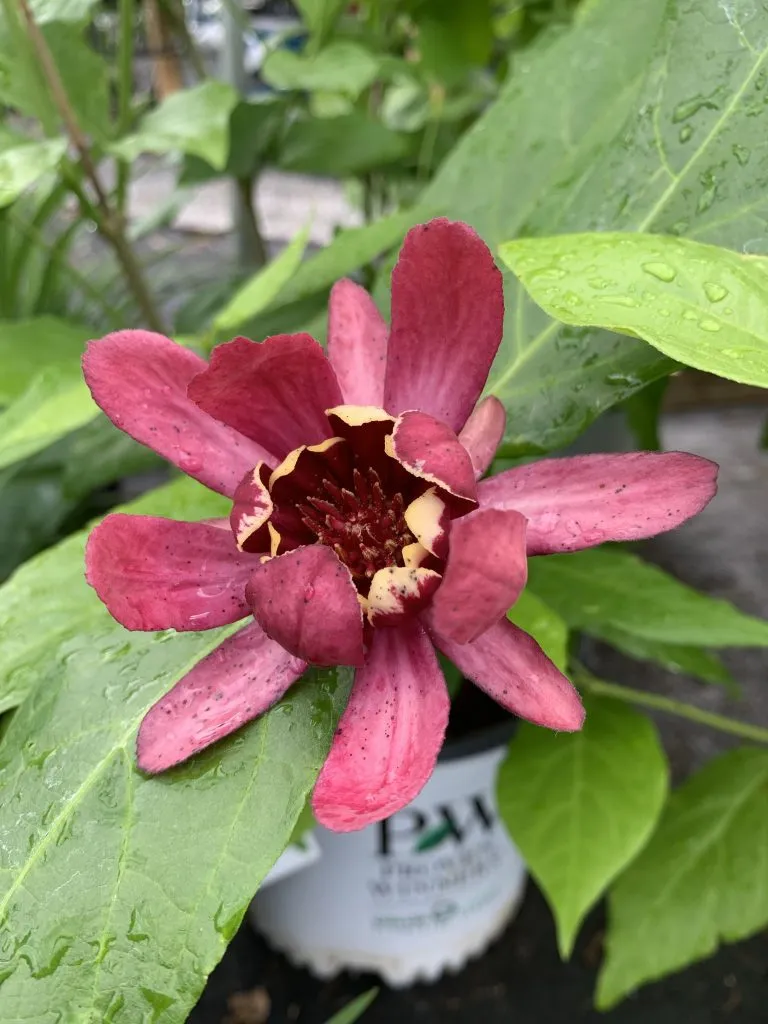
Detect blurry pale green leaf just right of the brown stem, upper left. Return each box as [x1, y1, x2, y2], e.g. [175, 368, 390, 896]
[110, 79, 238, 170]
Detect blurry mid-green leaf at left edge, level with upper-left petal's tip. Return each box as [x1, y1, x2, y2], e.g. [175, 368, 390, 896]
[0, 316, 93, 404]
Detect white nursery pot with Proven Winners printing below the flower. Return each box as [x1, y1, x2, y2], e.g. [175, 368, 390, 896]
[251, 726, 525, 985]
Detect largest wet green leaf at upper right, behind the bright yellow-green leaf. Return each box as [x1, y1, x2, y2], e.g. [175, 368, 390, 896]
[426, 0, 768, 453]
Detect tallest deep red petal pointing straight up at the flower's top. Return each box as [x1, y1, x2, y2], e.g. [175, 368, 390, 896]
[384, 220, 504, 431]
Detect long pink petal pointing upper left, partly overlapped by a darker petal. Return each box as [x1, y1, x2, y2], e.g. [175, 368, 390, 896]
[83, 331, 268, 495]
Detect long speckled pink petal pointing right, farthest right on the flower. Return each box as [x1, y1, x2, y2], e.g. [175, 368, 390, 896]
[477, 452, 718, 555]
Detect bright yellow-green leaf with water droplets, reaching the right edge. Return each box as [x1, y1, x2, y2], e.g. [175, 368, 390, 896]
[500, 231, 768, 387]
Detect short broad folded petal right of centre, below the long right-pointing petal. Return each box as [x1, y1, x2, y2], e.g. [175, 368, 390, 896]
[431, 509, 528, 643]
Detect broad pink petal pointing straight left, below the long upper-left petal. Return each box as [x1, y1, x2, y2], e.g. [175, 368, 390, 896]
[85, 512, 255, 631]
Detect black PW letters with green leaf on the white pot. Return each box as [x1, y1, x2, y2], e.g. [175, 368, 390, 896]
[379, 795, 494, 857]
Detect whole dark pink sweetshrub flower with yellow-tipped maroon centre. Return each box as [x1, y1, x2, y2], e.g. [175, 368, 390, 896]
[84, 220, 717, 830]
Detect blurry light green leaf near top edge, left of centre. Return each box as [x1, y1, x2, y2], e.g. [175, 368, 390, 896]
[261, 40, 379, 99]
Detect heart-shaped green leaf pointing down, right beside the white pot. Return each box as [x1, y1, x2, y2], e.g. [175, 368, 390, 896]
[498, 699, 668, 956]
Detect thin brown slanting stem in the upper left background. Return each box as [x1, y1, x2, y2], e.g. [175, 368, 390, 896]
[18, 0, 167, 334]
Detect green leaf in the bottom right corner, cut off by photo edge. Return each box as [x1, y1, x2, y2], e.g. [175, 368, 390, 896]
[597, 749, 768, 1010]
